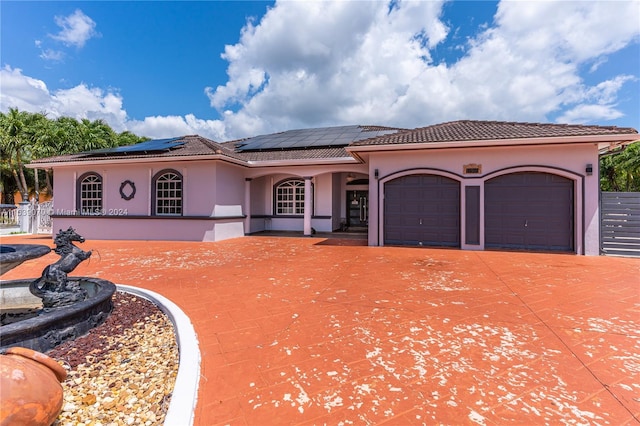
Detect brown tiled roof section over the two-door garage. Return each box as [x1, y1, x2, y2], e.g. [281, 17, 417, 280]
[350, 120, 638, 146]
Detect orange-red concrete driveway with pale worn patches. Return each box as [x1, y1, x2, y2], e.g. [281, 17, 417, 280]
[3, 237, 640, 425]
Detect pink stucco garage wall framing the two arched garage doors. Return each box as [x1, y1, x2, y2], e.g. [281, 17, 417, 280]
[369, 144, 599, 255]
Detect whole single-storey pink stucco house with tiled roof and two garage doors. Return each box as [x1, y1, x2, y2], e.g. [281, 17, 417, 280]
[31, 120, 638, 255]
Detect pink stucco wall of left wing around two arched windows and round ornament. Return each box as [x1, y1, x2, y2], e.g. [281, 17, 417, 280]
[53, 161, 244, 241]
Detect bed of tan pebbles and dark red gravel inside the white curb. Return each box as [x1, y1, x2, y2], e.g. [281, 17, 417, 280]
[47, 292, 179, 426]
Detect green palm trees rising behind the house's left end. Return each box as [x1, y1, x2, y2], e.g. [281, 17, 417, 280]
[0, 108, 146, 204]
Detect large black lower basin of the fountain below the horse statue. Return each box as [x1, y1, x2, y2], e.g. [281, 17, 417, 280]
[0, 277, 116, 352]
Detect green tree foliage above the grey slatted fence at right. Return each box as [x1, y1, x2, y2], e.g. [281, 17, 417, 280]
[600, 141, 640, 192]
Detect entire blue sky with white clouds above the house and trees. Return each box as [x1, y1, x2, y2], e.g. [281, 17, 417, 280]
[0, 0, 640, 141]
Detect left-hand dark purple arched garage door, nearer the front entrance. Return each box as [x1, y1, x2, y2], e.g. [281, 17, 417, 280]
[384, 174, 460, 247]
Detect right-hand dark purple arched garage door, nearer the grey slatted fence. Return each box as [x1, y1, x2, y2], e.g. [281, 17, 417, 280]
[484, 172, 575, 251]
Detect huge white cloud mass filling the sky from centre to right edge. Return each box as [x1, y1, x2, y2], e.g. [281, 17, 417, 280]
[206, 1, 640, 135]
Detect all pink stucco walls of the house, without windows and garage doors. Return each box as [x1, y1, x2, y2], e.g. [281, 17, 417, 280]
[47, 144, 600, 251]
